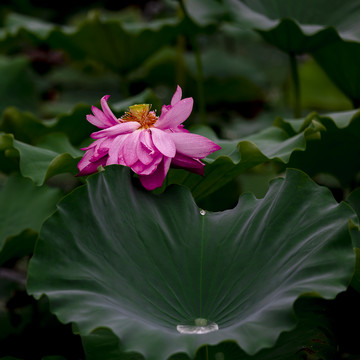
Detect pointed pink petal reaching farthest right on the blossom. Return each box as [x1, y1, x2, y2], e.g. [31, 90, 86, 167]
[169, 132, 221, 159]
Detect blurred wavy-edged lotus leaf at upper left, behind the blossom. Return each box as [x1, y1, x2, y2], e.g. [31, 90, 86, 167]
[0, 13, 180, 75]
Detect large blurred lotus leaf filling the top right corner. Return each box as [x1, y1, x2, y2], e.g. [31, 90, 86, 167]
[185, 0, 360, 107]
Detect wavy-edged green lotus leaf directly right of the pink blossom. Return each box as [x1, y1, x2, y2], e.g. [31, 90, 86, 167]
[167, 118, 324, 200]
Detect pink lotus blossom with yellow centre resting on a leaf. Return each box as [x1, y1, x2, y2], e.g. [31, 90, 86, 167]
[78, 86, 220, 190]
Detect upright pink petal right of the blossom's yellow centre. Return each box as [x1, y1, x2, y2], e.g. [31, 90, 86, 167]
[154, 98, 194, 129]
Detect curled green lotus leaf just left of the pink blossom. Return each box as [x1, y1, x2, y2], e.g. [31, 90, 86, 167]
[0, 133, 83, 185]
